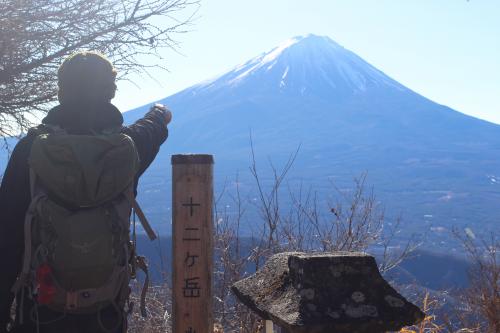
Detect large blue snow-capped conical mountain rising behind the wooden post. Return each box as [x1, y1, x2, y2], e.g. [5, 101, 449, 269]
[124, 35, 500, 250]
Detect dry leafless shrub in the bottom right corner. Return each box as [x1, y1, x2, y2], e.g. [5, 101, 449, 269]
[401, 229, 500, 333]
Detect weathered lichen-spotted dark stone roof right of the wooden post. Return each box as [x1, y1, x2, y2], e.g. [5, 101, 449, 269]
[232, 252, 424, 333]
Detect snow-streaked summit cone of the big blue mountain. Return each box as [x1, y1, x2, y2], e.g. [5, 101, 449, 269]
[189, 34, 403, 97]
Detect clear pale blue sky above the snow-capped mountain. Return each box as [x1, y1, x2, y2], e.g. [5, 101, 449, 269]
[114, 0, 500, 124]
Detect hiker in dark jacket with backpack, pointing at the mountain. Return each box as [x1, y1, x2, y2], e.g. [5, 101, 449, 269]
[0, 52, 172, 333]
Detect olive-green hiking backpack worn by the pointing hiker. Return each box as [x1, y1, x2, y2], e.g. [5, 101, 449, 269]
[13, 126, 155, 321]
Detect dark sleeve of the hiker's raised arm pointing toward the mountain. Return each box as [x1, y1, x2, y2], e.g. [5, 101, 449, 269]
[122, 109, 168, 188]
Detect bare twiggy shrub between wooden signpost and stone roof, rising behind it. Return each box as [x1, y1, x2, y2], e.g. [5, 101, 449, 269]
[209, 147, 414, 333]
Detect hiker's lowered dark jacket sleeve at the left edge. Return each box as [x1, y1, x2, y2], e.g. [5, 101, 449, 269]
[0, 136, 33, 332]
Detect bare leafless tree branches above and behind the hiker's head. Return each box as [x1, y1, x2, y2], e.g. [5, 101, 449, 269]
[0, 0, 198, 136]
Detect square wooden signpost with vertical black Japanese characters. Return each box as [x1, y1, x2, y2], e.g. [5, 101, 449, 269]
[172, 155, 213, 333]
